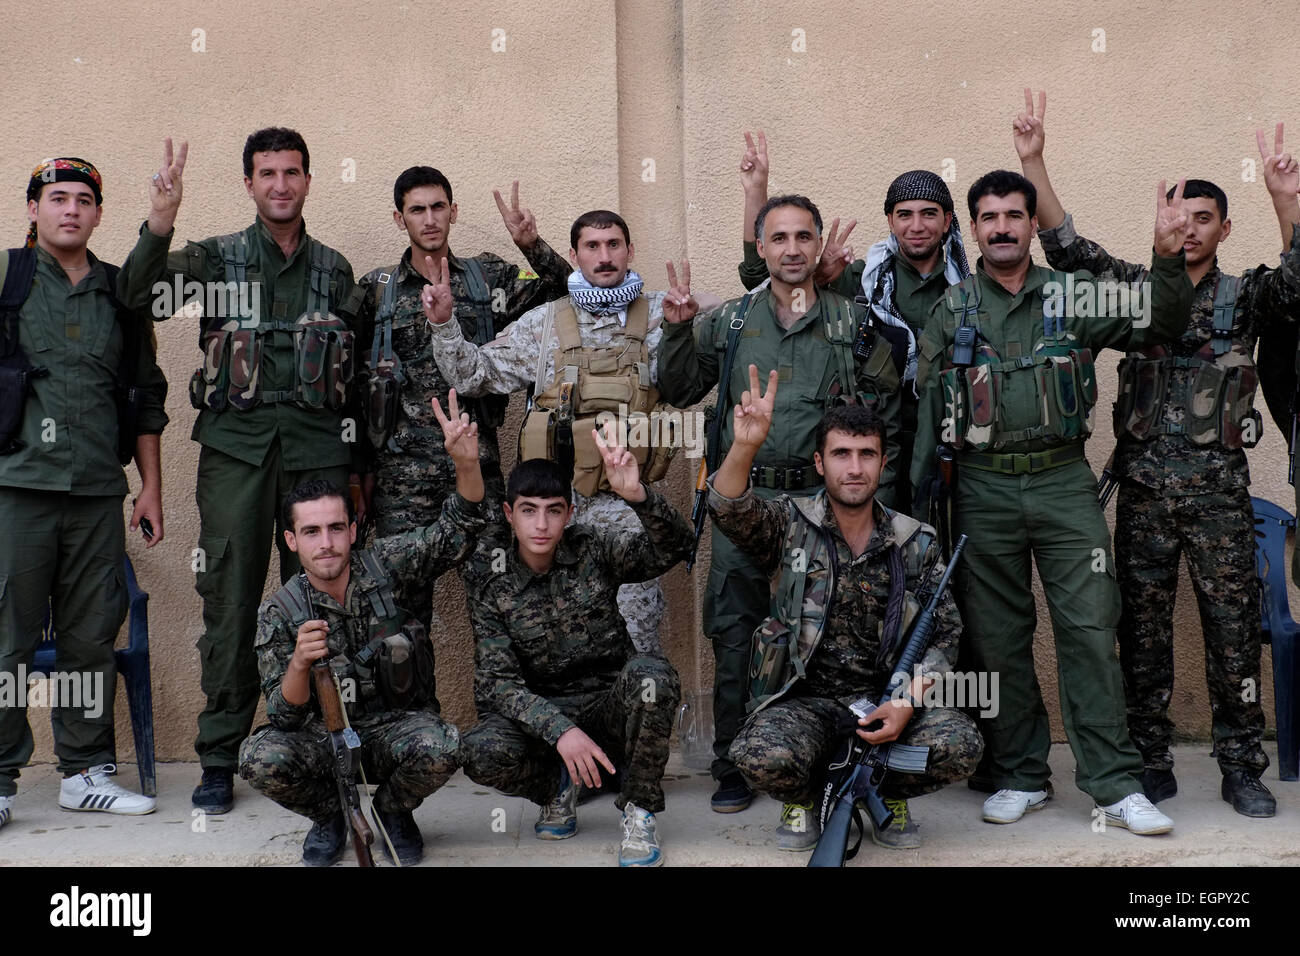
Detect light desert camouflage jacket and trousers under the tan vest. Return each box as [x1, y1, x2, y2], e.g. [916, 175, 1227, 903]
[432, 293, 664, 655]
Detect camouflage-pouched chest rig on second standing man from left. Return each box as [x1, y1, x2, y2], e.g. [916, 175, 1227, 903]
[190, 233, 354, 412]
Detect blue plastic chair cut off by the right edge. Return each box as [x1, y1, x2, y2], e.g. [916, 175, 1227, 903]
[1251, 498, 1300, 780]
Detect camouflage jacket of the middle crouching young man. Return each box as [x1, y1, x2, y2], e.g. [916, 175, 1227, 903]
[462, 488, 693, 744]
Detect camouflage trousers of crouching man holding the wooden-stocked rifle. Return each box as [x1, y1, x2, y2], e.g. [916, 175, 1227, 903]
[239, 710, 460, 821]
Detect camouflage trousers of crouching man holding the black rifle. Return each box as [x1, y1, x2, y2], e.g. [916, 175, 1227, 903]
[731, 697, 984, 805]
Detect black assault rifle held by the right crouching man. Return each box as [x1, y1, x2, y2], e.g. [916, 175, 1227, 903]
[809, 535, 966, 866]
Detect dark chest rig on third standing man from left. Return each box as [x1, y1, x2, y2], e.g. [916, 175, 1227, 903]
[367, 252, 510, 449]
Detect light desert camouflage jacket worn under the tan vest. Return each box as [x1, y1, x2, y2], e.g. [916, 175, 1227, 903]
[432, 293, 664, 395]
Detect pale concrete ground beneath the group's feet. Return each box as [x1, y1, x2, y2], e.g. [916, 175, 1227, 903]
[0, 743, 1300, 866]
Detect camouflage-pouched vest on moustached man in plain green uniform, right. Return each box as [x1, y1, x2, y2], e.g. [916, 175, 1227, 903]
[939, 272, 1097, 451]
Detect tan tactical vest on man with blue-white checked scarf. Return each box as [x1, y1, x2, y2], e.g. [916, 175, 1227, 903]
[519, 295, 681, 497]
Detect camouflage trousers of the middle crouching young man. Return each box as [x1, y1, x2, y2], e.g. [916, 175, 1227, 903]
[462, 657, 681, 813]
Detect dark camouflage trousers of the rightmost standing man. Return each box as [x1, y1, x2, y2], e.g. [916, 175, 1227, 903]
[1115, 481, 1269, 773]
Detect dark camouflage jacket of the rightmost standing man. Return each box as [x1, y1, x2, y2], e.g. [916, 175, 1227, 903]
[1039, 215, 1300, 494]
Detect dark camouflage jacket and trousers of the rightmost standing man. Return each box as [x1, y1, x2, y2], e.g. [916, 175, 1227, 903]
[1039, 216, 1300, 775]
